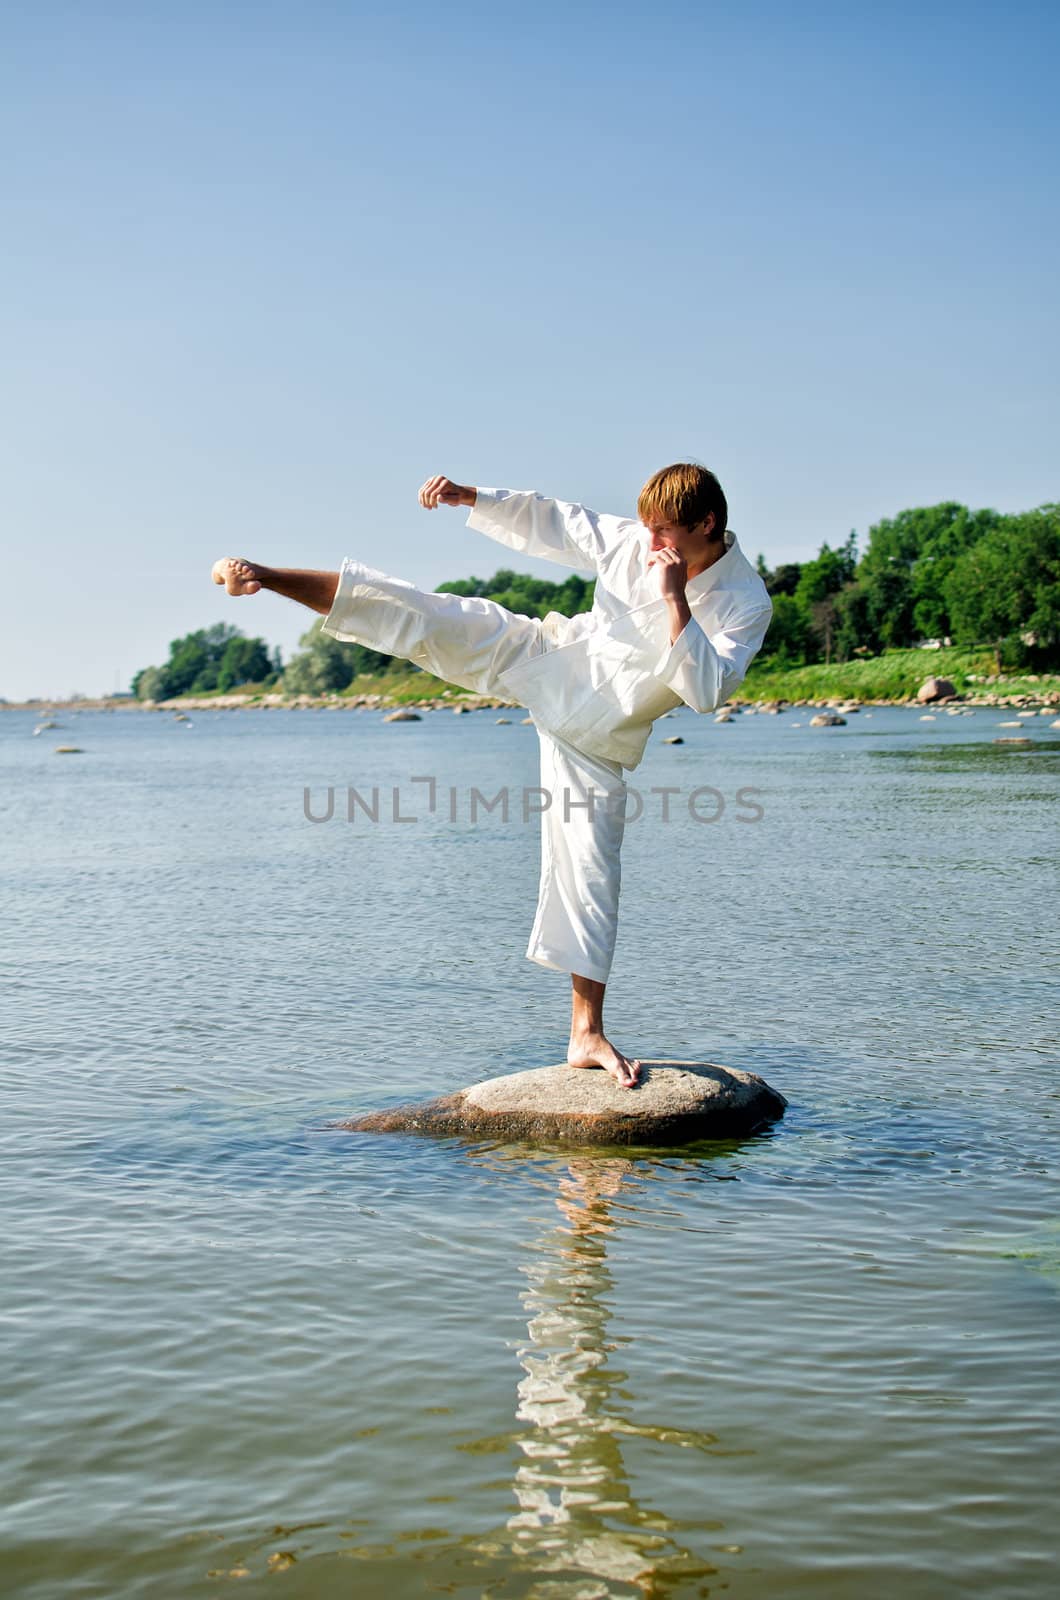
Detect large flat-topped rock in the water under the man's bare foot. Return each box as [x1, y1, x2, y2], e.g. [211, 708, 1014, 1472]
[338, 1061, 788, 1146]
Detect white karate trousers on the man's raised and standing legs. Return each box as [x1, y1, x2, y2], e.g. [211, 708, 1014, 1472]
[323, 560, 626, 982]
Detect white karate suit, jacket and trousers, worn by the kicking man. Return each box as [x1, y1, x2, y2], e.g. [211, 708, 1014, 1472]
[323, 490, 772, 982]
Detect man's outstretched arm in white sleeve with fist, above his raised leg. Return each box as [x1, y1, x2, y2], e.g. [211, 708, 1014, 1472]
[420, 475, 632, 573]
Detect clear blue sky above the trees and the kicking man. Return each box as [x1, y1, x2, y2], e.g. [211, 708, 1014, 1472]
[0, 0, 1060, 699]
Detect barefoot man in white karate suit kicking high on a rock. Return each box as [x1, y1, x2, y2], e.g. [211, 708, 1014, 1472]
[213, 462, 772, 1088]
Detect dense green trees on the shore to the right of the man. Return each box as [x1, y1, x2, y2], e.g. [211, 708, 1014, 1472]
[759, 501, 1060, 669]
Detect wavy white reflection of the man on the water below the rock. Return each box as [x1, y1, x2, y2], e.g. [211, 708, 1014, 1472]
[480, 1157, 730, 1600]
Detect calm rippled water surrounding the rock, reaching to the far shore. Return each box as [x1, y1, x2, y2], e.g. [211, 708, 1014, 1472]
[0, 709, 1060, 1600]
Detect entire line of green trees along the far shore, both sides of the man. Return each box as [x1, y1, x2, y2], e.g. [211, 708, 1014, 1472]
[133, 501, 1060, 699]
